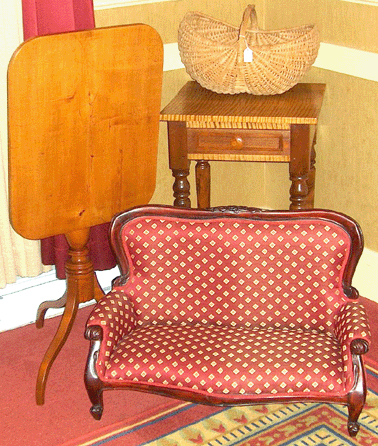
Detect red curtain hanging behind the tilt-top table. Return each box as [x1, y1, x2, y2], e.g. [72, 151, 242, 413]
[22, 0, 116, 279]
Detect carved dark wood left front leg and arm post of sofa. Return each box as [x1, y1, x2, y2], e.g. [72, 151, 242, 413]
[85, 327, 104, 420]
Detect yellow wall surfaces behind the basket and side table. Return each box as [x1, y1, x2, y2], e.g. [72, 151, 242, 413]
[96, 0, 378, 251]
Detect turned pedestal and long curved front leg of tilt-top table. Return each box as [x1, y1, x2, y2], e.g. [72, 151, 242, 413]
[36, 229, 103, 405]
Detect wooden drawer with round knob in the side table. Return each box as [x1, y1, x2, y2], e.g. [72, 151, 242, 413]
[187, 128, 290, 159]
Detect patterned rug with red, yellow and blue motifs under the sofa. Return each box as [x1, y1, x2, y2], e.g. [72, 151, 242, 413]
[62, 368, 378, 446]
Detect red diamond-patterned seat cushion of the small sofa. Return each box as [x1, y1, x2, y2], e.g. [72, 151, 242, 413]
[105, 324, 346, 398]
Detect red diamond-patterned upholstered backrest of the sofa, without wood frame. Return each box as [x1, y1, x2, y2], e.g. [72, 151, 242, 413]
[113, 207, 362, 331]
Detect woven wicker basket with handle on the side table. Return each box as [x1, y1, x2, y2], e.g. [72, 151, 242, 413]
[178, 5, 320, 95]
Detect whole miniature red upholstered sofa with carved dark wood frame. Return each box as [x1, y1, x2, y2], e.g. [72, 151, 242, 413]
[85, 206, 370, 436]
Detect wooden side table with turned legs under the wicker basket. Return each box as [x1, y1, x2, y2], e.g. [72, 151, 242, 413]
[160, 81, 325, 210]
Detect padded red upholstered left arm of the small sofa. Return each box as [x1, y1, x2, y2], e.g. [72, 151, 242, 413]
[85, 289, 136, 377]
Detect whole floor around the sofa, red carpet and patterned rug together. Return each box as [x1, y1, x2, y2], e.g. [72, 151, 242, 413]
[0, 294, 378, 446]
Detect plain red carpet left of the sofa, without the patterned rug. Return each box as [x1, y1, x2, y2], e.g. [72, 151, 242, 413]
[0, 307, 183, 446]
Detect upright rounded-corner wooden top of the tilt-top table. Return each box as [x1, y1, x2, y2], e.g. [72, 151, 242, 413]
[8, 25, 163, 239]
